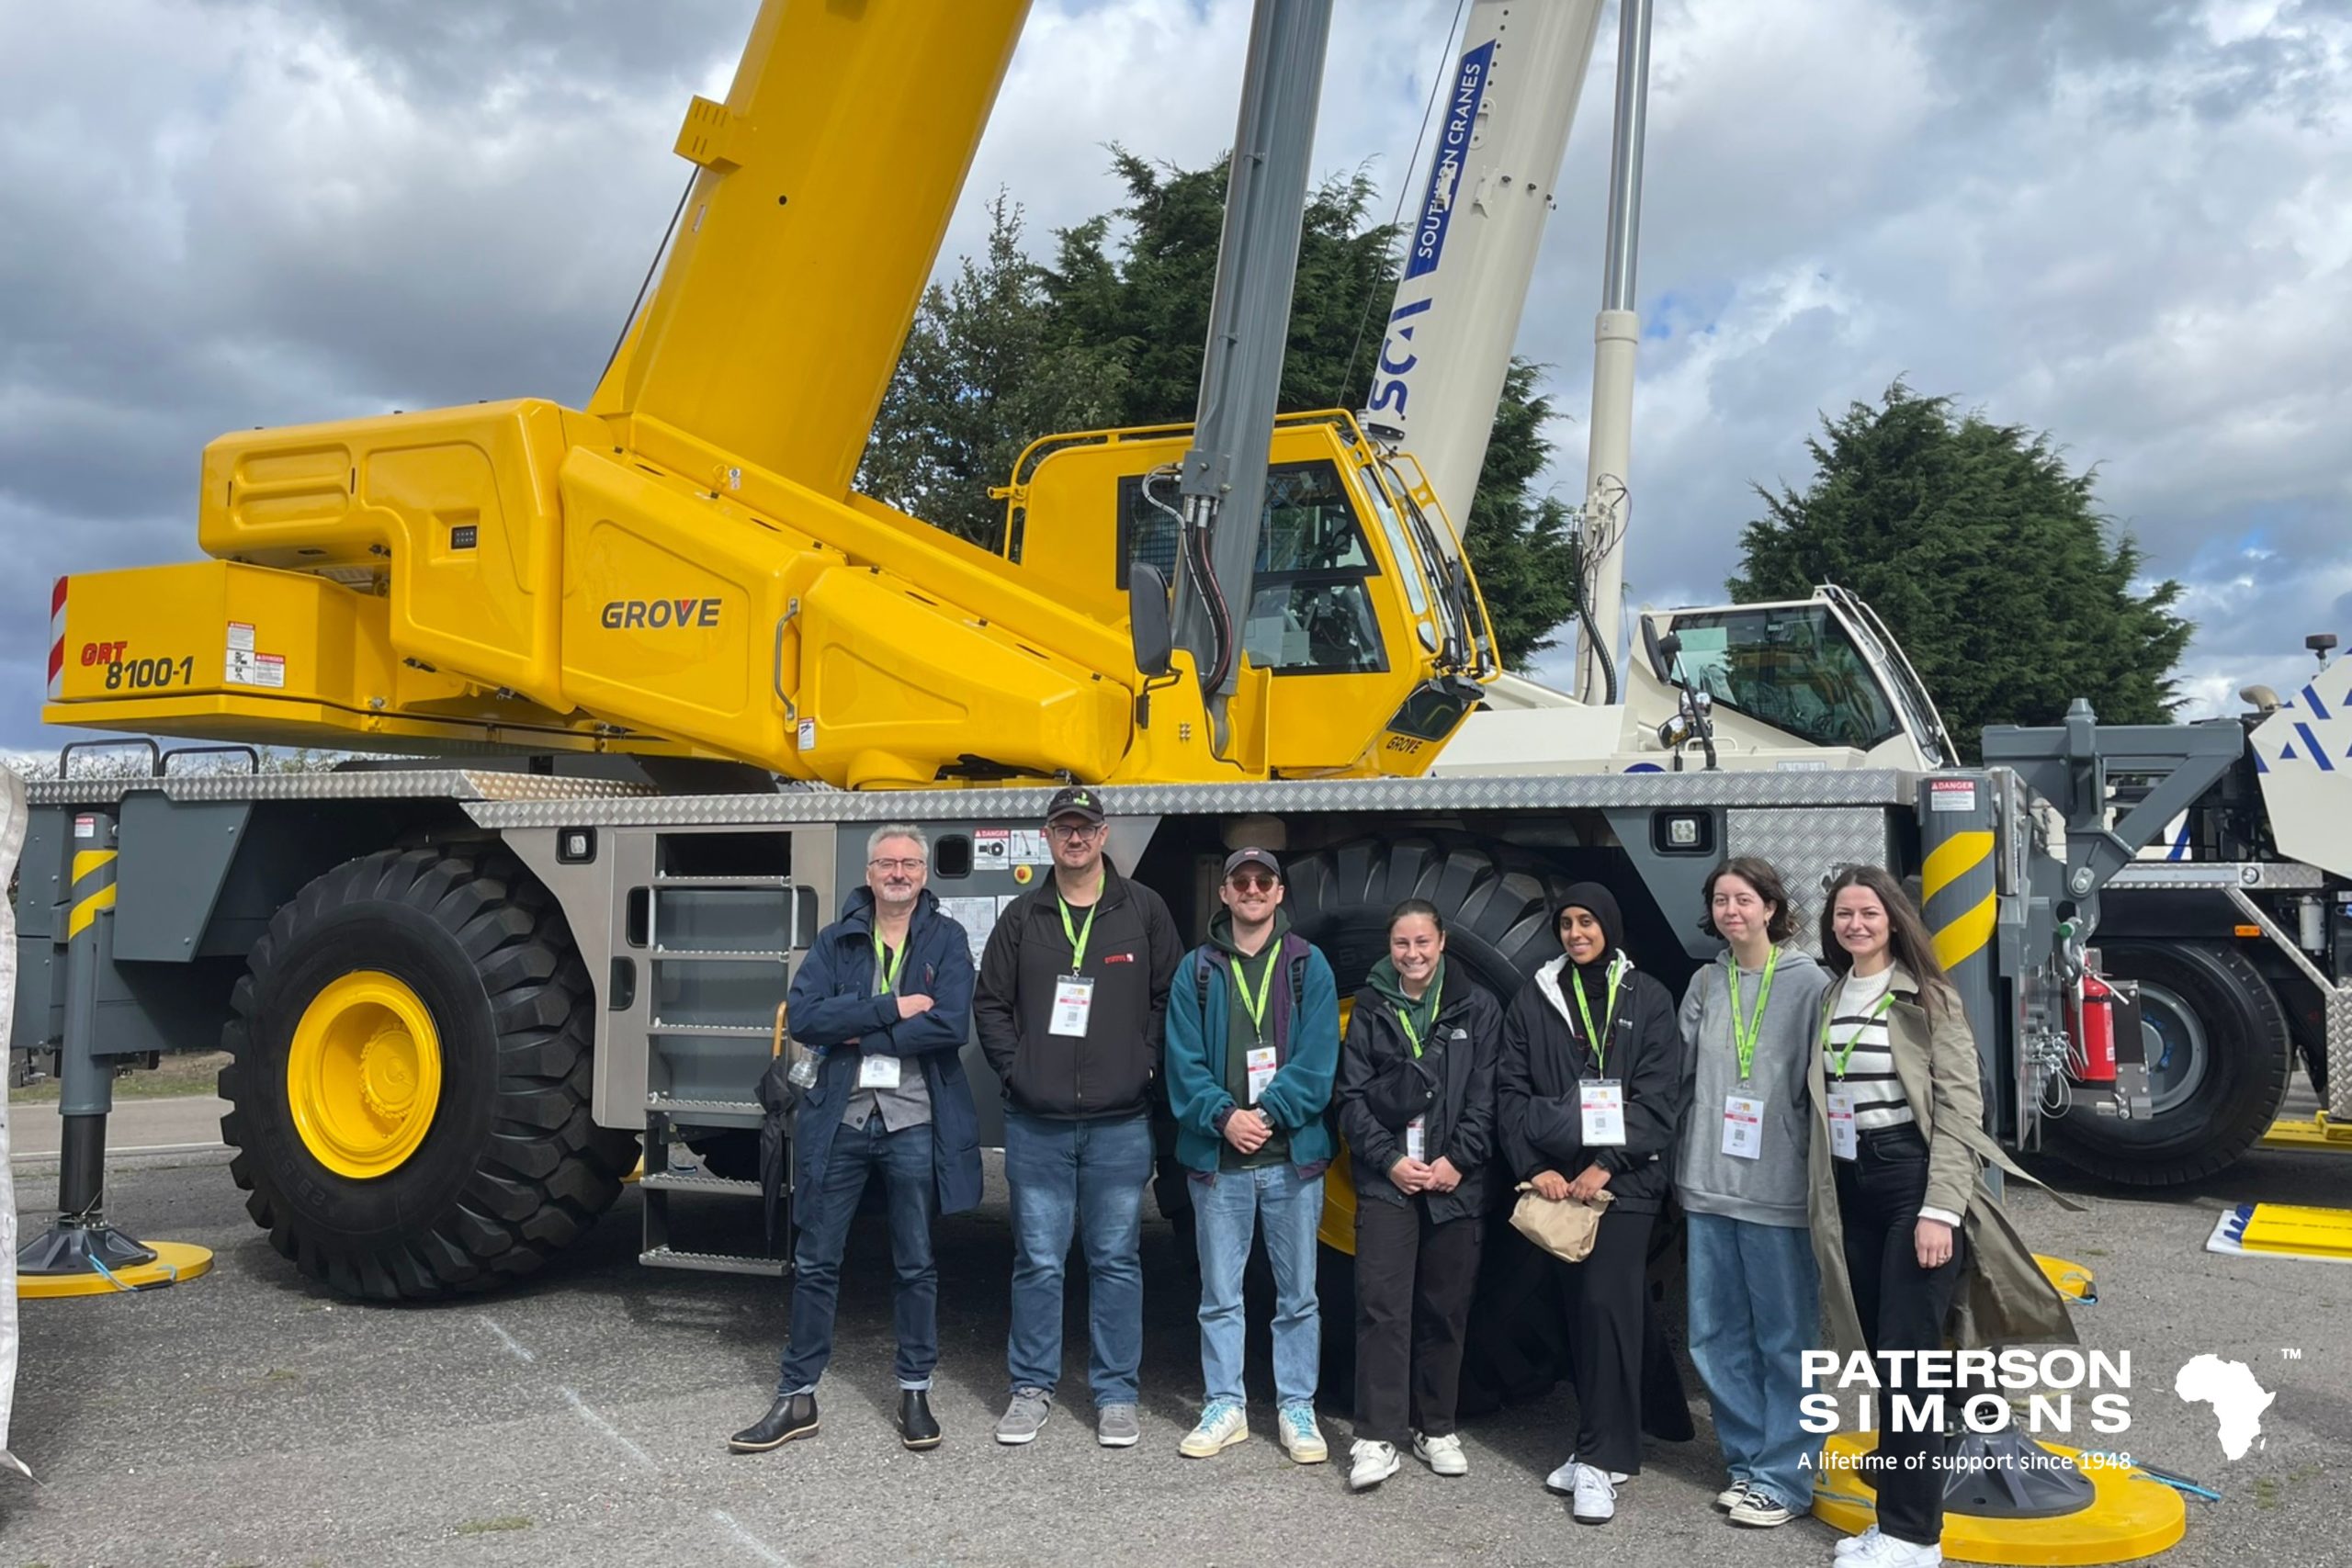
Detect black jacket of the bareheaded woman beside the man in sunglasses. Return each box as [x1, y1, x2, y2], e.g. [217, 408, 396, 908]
[1331, 976, 1503, 1220]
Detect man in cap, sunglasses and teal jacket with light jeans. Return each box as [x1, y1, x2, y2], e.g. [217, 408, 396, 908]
[1167, 849, 1339, 1464]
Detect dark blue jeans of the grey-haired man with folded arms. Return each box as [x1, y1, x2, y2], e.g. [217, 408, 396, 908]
[776, 1112, 938, 1399]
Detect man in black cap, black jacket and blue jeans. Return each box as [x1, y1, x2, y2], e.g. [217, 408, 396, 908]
[971, 785, 1183, 1448]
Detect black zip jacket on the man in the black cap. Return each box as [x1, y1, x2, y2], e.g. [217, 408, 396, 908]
[971, 861, 1183, 1122]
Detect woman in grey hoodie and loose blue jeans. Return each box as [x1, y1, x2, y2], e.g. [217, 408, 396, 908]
[1675, 856, 1830, 1528]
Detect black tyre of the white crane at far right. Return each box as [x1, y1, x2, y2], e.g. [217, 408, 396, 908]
[2051, 941, 2293, 1187]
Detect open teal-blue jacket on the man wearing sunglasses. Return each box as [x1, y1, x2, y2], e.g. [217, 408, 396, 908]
[1167, 941, 1339, 1170]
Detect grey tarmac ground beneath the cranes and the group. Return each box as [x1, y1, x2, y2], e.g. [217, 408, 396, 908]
[0, 1107, 2352, 1568]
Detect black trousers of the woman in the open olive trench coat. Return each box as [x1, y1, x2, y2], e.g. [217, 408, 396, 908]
[1835, 1126, 1969, 1547]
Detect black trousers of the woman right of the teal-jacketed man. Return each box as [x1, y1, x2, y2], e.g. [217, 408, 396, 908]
[1355, 1194, 1487, 1448]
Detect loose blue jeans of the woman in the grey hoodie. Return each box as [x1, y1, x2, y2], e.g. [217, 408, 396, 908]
[1689, 1213, 1820, 1514]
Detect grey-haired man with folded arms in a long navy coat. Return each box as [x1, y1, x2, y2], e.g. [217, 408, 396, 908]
[727, 825, 981, 1453]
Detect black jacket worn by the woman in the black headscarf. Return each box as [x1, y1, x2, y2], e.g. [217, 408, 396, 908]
[1496, 957, 1684, 1213]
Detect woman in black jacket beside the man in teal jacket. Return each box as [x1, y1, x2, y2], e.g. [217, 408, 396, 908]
[1334, 898, 1503, 1491]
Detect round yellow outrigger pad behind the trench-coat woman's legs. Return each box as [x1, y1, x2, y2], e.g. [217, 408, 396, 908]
[1814, 1432, 2189, 1568]
